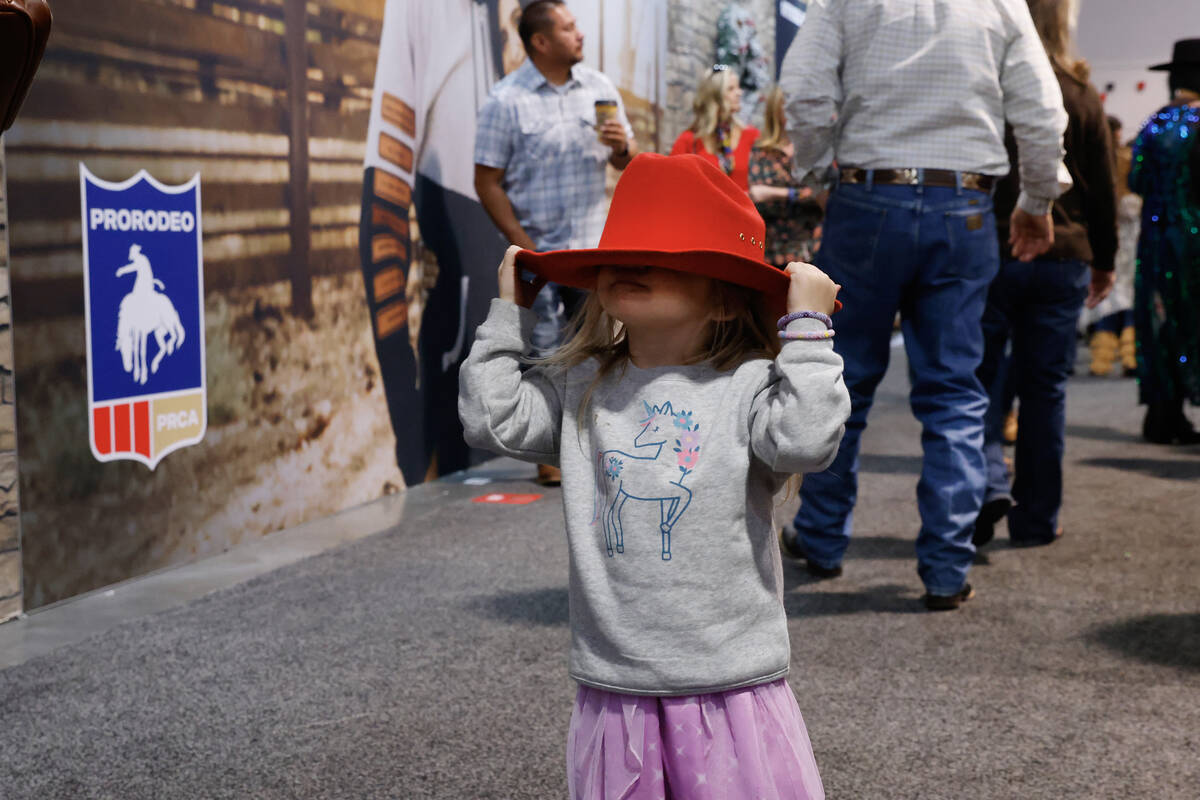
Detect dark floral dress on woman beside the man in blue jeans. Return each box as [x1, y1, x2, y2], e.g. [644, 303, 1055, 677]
[750, 148, 822, 267]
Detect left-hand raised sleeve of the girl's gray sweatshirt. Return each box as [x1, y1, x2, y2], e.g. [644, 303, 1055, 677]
[458, 299, 563, 467]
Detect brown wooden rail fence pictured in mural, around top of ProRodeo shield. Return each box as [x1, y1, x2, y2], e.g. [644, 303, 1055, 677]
[7, 0, 383, 324]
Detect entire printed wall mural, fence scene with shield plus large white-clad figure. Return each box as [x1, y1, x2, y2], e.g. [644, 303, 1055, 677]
[5, 0, 672, 609]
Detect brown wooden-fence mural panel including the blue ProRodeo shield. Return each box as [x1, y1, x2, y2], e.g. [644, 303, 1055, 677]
[7, 0, 405, 610]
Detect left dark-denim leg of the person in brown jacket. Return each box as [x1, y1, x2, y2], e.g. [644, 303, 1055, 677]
[977, 267, 1016, 503]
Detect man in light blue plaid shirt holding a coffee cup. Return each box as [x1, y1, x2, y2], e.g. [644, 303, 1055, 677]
[475, 0, 637, 483]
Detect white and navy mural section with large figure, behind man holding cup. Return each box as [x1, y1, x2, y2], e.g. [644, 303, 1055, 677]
[359, 0, 667, 485]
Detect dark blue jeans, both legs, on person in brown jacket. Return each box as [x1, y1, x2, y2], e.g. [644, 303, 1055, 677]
[979, 260, 1090, 543]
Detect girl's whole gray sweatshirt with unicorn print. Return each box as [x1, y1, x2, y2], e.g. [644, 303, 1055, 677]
[458, 300, 850, 696]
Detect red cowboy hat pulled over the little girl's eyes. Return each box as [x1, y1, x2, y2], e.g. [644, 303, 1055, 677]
[517, 152, 841, 314]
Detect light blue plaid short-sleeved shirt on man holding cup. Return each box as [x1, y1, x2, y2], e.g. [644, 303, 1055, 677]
[475, 60, 634, 251]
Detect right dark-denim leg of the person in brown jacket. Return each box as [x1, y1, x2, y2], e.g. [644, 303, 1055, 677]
[1006, 261, 1090, 542]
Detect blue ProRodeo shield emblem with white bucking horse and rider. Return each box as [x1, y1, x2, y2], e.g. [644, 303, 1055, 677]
[79, 163, 208, 469]
